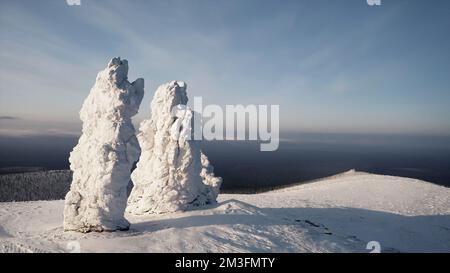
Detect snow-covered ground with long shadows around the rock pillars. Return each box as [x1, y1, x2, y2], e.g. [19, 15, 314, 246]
[0, 172, 450, 252]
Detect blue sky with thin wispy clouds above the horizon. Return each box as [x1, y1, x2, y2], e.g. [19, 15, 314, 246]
[0, 0, 450, 135]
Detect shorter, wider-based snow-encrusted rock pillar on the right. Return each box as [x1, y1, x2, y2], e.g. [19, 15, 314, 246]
[127, 81, 222, 215]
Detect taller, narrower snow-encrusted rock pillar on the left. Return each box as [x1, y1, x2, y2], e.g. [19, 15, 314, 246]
[64, 58, 144, 232]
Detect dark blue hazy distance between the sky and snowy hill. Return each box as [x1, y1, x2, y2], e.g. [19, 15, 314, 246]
[0, 134, 450, 192]
